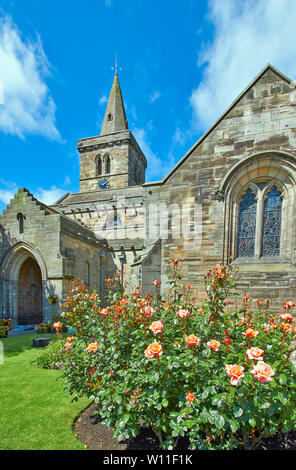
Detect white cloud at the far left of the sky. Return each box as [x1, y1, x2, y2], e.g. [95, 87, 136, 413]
[0, 12, 61, 141]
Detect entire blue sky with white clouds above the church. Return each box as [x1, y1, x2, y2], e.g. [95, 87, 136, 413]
[0, 0, 296, 211]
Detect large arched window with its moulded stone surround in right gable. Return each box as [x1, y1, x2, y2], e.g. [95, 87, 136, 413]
[220, 152, 296, 264]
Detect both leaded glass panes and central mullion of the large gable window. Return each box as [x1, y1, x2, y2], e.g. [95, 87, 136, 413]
[237, 182, 282, 257]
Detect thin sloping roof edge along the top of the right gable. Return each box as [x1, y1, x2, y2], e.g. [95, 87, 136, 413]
[144, 64, 296, 186]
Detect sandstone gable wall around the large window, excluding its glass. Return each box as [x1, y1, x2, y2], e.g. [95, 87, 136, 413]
[144, 69, 296, 309]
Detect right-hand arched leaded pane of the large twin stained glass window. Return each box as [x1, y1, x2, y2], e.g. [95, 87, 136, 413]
[262, 186, 282, 256]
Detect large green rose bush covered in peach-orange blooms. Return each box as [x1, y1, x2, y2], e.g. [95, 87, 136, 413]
[58, 260, 296, 449]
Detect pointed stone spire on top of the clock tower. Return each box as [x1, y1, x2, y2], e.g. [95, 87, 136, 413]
[100, 70, 128, 135]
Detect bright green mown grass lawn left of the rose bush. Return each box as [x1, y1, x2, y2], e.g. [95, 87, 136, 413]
[0, 334, 89, 450]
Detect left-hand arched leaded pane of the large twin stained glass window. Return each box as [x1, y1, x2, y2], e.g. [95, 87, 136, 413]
[238, 188, 257, 257]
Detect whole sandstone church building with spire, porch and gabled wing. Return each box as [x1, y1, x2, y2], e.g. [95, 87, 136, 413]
[0, 64, 296, 325]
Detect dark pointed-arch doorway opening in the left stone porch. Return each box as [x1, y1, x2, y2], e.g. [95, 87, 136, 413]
[17, 256, 43, 325]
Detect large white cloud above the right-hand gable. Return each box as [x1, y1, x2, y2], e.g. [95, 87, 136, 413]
[190, 0, 296, 130]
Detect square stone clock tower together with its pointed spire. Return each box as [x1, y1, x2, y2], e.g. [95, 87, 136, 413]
[78, 70, 147, 192]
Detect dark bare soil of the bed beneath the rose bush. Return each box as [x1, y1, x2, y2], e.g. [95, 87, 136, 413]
[74, 404, 296, 451]
